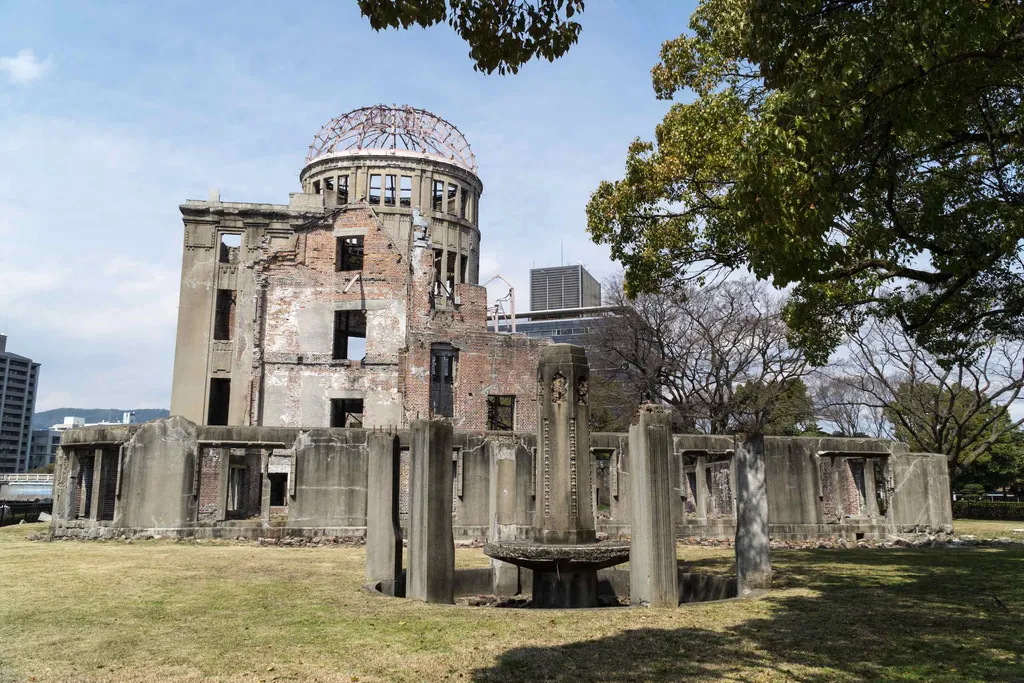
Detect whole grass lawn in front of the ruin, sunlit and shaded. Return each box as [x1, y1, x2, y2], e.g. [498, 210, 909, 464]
[0, 524, 1024, 683]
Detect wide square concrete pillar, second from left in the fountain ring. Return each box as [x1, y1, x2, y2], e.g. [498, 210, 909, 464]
[406, 420, 455, 603]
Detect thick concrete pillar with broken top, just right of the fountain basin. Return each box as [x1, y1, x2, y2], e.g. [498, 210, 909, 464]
[630, 405, 679, 607]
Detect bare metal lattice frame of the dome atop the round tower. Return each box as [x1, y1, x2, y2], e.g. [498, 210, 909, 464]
[306, 104, 476, 173]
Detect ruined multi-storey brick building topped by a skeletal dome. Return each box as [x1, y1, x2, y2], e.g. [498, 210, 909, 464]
[171, 105, 544, 430]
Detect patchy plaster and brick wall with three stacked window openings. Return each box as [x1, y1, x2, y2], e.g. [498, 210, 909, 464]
[261, 207, 409, 427]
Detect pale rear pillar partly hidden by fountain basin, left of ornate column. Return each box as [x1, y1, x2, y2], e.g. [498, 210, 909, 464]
[487, 436, 519, 595]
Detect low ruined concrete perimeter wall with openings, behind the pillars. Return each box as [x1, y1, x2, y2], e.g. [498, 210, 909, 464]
[52, 417, 952, 540]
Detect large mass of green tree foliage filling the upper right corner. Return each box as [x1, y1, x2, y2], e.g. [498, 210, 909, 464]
[587, 0, 1024, 365]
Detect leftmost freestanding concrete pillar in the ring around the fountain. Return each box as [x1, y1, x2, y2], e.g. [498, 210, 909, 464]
[367, 433, 401, 585]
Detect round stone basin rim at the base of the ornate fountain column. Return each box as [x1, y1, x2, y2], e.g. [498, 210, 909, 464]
[483, 541, 630, 571]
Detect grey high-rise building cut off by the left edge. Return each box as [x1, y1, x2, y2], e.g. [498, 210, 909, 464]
[0, 335, 39, 474]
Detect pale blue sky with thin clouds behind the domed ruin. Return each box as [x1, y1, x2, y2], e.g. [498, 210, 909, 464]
[0, 0, 694, 410]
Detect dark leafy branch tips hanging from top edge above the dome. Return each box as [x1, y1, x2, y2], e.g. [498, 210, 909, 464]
[358, 0, 584, 74]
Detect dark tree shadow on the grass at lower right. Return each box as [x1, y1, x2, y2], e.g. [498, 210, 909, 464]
[473, 550, 1024, 683]
